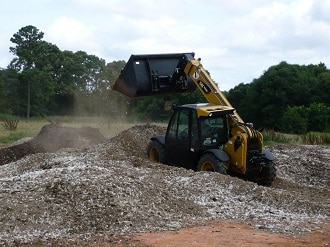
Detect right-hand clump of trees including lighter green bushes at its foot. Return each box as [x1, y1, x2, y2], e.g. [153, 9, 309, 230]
[228, 62, 330, 134]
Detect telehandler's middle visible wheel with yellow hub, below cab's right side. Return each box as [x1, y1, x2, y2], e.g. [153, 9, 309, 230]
[197, 153, 227, 175]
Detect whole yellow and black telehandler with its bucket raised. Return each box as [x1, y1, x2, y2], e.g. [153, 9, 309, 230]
[112, 52, 276, 186]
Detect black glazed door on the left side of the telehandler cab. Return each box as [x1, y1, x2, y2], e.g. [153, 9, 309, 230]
[165, 108, 198, 169]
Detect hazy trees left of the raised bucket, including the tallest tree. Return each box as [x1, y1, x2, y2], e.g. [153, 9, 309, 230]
[0, 26, 125, 118]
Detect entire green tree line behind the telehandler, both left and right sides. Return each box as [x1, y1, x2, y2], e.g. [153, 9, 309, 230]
[0, 26, 330, 134]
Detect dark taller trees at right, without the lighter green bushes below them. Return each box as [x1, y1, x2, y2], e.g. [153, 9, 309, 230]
[228, 62, 330, 131]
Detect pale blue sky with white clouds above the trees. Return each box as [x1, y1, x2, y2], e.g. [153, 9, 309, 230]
[0, 0, 330, 91]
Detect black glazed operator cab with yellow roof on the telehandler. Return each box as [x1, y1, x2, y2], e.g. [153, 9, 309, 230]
[165, 104, 234, 170]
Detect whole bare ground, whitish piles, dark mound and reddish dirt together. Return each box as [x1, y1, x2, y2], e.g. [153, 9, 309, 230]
[0, 125, 330, 247]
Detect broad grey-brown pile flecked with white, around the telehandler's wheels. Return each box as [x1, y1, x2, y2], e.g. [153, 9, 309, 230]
[0, 125, 330, 246]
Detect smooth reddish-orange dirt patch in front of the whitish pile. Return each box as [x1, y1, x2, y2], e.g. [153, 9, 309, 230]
[135, 220, 330, 247]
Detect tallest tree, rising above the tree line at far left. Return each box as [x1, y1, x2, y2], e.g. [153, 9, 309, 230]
[9, 26, 69, 118]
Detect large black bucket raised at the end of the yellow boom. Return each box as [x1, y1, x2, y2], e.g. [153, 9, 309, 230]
[112, 53, 196, 97]
